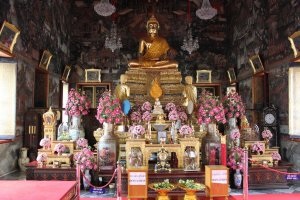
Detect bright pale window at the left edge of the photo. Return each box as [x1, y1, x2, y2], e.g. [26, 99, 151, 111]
[0, 63, 17, 140]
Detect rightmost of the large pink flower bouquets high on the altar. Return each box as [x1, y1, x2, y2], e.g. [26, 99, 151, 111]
[223, 92, 245, 119]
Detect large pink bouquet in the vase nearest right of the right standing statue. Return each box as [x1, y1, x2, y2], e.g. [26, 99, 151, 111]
[198, 91, 226, 124]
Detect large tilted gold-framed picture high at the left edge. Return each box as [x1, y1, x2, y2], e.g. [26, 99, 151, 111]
[0, 21, 20, 54]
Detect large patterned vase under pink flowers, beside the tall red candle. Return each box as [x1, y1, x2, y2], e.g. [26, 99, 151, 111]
[201, 123, 221, 167]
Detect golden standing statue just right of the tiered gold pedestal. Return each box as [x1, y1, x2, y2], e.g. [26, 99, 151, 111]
[182, 76, 197, 114]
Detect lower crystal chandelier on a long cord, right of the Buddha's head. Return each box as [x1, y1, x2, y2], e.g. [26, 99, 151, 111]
[181, 0, 199, 54]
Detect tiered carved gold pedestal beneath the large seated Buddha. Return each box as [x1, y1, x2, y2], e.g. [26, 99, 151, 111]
[126, 69, 183, 105]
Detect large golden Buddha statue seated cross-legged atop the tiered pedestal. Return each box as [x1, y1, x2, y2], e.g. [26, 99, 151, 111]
[128, 16, 178, 69]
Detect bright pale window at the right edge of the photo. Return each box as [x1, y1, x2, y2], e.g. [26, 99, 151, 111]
[289, 67, 300, 136]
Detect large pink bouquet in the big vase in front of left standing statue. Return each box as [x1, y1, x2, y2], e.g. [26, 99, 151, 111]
[96, 91, 123, 124]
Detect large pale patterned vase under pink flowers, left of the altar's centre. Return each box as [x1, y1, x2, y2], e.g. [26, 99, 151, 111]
[97, 122, 117, 170]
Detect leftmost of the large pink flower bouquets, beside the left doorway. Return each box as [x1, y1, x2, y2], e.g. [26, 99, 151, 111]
[66, 88, 91, 116]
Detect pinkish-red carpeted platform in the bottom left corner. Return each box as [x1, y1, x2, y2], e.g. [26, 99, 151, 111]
[0, 180, 76, 200]
